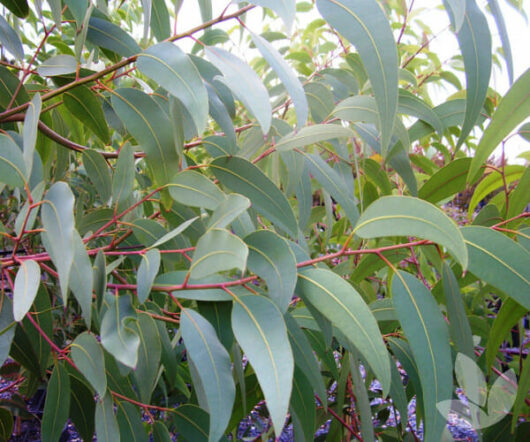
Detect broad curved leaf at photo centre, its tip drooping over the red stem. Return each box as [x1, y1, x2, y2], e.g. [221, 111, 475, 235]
[244, 230, 297, 313]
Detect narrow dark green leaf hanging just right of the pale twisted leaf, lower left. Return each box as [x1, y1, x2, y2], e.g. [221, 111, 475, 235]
[131, 313, 162, 404]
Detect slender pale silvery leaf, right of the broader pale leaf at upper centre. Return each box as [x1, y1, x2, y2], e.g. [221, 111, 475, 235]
[250, 31, 309, 127]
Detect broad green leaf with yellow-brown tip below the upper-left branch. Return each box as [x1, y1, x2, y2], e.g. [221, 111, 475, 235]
[112, 88, 179, 185]
